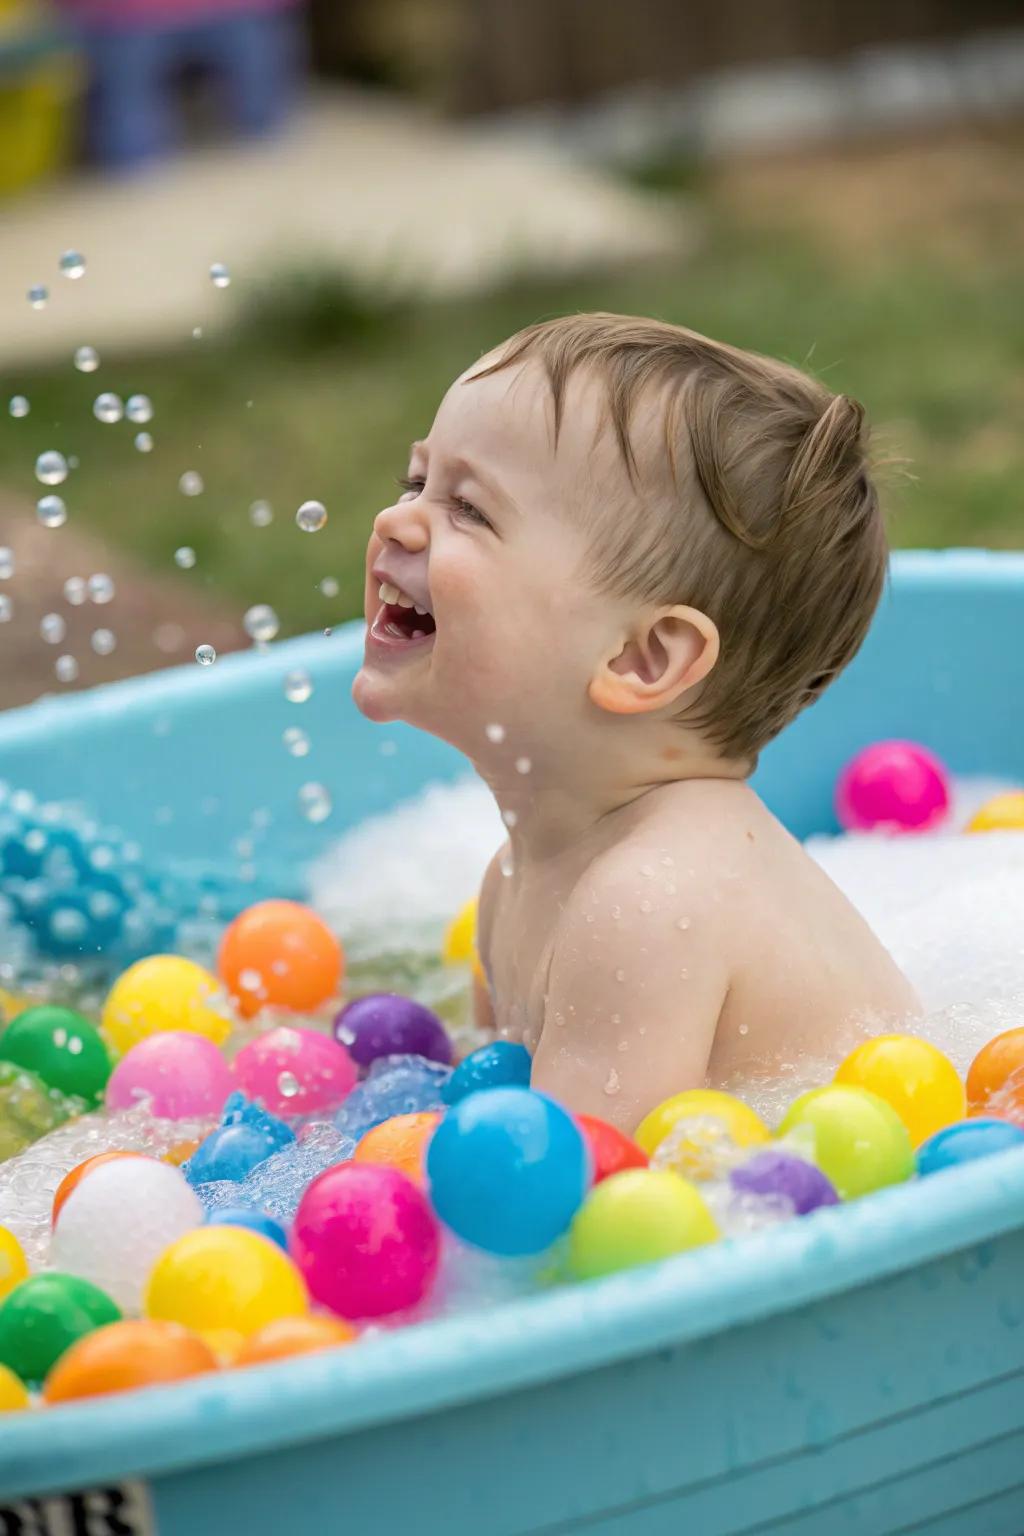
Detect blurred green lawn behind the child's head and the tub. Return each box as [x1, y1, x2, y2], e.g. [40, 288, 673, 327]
[0, 220, 1024, 633]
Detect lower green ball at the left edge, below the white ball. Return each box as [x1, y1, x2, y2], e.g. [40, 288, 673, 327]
[0, 1275, 121, 1387]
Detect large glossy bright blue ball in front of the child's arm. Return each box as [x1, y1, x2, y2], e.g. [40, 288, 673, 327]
[427, 1087, 591, 1256]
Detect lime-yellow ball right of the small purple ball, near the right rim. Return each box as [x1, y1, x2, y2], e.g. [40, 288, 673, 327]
[778, 1083, 913, 1200]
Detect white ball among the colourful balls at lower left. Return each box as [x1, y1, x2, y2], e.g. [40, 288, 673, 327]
[49, 1157, 203, 1316]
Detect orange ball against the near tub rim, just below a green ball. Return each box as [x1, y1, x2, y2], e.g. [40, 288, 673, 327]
[43, 1319, 218, 1402]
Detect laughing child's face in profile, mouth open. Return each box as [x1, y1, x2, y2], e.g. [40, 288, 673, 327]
[353, 354, 625, 765]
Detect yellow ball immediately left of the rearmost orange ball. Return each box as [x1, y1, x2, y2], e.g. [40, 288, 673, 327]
[103, 955, 232, 1055]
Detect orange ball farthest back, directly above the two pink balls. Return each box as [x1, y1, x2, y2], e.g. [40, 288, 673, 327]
[218, 902, 345, 1018]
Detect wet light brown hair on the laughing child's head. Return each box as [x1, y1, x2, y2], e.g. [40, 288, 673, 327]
[471, 312, 887, 760]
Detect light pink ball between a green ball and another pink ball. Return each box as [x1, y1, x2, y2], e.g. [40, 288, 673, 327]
[106, 1029, 233, 1120]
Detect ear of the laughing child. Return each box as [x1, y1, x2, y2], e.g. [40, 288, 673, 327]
[588, 607, 720, 714]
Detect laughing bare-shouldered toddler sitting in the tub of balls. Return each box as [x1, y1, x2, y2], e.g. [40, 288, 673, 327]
[353, 313, 918, 1130]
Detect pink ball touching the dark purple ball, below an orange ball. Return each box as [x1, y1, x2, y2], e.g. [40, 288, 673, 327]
[235, 1025, 356, 1115]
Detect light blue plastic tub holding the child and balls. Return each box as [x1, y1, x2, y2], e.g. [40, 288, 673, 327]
[0, 551, 1024, 1536]
